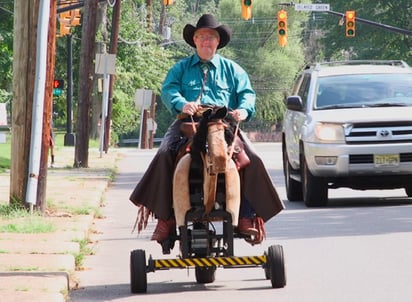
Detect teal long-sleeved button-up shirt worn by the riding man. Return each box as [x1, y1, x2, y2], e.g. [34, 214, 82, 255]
[161, 54, 256, 120]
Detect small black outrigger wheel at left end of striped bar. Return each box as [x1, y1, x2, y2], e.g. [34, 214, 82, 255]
[130, 250, 147, 294]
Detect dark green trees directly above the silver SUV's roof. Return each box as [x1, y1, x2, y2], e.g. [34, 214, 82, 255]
[321, 0, 412, 65]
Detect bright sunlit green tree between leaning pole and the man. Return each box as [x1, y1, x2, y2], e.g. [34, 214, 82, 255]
[104, 1, 173, 139]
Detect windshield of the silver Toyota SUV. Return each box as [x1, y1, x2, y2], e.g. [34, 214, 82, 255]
[314, 74, 412, 109]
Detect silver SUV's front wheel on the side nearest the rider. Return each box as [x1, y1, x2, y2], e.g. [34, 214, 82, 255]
[302, 156, 328, 207]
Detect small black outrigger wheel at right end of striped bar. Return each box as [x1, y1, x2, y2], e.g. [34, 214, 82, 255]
[265, 244, 286, 288]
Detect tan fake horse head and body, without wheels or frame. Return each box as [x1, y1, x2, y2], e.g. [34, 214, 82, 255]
[173, 107, 241, 232]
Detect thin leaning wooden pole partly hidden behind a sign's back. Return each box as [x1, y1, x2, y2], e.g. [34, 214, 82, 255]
[103, 1, 122, 153]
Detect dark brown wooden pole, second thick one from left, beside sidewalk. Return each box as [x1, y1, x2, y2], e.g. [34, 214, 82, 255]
[73, 0, 99, 168]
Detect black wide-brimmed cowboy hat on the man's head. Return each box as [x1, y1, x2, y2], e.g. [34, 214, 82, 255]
[183, 14, 232, 49]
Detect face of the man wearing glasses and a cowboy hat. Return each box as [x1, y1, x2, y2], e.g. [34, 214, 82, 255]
[193, 28, 220, 61]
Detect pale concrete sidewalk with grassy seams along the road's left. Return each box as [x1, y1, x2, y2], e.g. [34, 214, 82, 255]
[0, 147, 122, 302]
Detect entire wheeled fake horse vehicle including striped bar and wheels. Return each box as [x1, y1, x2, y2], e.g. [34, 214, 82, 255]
[130, 107, 286, 293]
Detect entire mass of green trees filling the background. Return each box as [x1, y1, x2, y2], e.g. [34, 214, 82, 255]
[0, 0, 412, 142]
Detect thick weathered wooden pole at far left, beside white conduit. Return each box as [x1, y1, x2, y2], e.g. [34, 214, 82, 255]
[10, 0, 39, 203]
